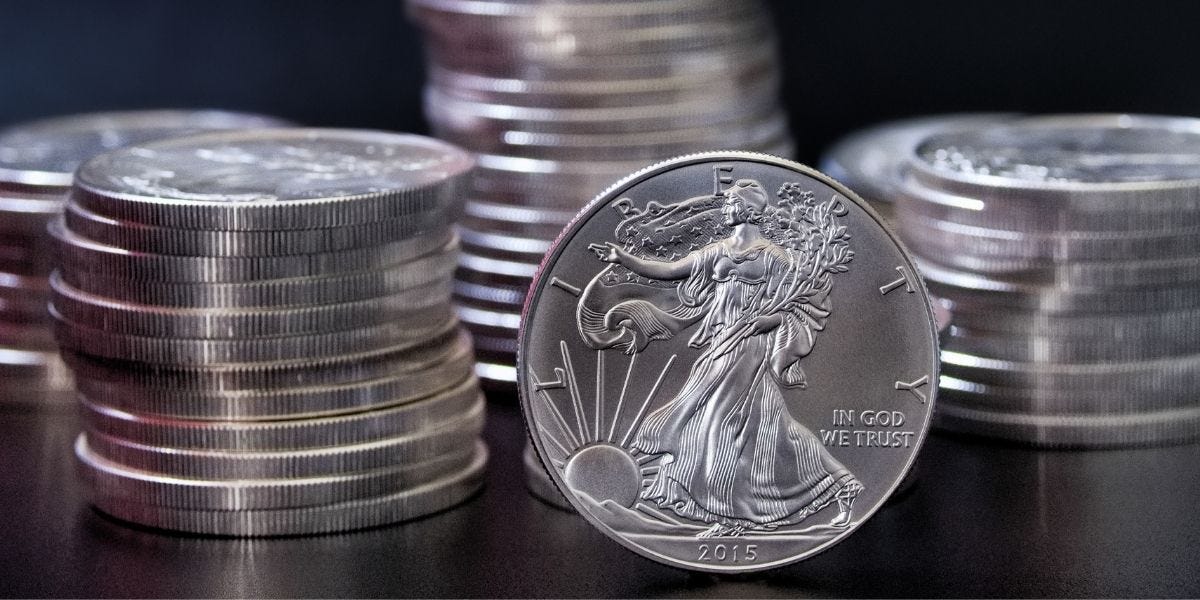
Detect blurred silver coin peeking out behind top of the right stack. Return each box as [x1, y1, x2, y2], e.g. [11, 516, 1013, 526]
[821, 113, 1016, 208]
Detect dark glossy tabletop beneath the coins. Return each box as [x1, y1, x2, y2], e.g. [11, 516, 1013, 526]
[0, 391, 1200, 596]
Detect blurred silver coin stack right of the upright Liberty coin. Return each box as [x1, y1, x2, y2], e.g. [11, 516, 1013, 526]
[896, 115, 1200, 448]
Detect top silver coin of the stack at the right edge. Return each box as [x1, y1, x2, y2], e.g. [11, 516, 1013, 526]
[901, 115, 1200, 232]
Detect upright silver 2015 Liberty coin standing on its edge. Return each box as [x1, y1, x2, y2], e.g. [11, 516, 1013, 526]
[517, 151, 938, 572]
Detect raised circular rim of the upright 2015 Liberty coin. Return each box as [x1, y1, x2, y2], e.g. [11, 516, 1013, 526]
[516, 150, 941, 572]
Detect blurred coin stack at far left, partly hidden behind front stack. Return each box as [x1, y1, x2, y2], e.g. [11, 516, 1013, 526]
[0, 110, 282, 406]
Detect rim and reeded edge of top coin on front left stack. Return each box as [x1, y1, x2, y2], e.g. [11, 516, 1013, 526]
[71, 128, 474, 230]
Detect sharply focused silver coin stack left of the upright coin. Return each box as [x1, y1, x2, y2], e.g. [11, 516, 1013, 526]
[50, 130, 487, 535]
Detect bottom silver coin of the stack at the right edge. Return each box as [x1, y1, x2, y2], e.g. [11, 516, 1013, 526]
[935, 402, 1200, 449]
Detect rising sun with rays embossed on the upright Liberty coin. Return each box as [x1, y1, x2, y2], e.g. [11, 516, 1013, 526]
[530, 341, 682, 524]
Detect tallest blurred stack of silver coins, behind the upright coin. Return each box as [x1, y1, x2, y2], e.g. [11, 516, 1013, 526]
[408, 0, 792, 392]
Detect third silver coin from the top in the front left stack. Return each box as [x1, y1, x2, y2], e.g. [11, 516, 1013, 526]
[49, 217, 454, 283]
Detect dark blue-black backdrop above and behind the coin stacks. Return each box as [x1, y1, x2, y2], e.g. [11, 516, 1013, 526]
[0, 0, 1200, 162]
